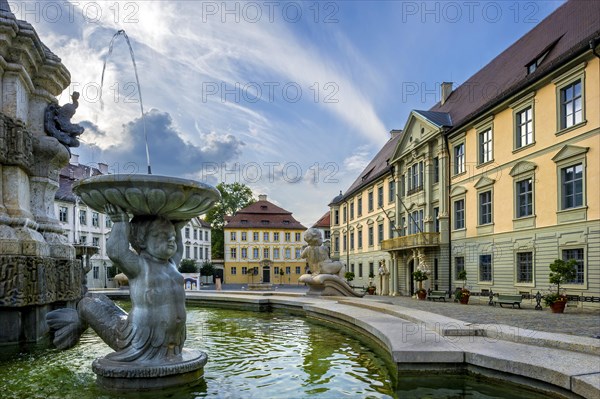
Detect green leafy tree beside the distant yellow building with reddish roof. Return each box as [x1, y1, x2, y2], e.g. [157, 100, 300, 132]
[205, 182, 255, 259]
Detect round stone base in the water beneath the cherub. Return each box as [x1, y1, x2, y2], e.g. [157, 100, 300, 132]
[92, 349, 208, 392]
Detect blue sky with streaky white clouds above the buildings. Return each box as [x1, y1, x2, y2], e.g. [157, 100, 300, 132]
[16, 0, 562, 227]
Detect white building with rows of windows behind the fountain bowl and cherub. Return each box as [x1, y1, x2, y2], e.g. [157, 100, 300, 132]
[54, 155, 211, 288]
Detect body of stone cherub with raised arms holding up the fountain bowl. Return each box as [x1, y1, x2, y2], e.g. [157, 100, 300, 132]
[105, 204, 187, 363]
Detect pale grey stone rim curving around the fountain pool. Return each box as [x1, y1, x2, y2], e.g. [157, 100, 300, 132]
[95, 290, 600, 398]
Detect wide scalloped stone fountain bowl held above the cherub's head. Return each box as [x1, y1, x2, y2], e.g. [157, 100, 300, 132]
[73, 174, 221, 220]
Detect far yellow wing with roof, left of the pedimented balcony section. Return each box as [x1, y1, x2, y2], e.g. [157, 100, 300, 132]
[329, 130, 402, 292]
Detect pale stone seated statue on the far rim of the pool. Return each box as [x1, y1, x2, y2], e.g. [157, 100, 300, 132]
[299, 228, 362, 297]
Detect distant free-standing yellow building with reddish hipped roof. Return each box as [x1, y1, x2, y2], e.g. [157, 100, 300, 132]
[223, 195, 307, 284]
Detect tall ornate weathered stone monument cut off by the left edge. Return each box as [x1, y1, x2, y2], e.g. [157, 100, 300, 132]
[0, 0, 84, 344]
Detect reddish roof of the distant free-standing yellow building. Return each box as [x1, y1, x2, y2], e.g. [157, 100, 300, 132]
[225, 200, 306, 230]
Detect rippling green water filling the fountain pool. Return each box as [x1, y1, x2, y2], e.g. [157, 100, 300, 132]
[0, 308, 542, 399]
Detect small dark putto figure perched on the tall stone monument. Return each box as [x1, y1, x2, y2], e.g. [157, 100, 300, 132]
[44, 91, 85, 149]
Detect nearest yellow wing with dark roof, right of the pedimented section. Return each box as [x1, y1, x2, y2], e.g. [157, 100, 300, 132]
[424, 1, 600, 301]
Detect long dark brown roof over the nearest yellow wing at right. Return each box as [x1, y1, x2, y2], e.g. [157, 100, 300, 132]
[430, 0, 600, 133]
